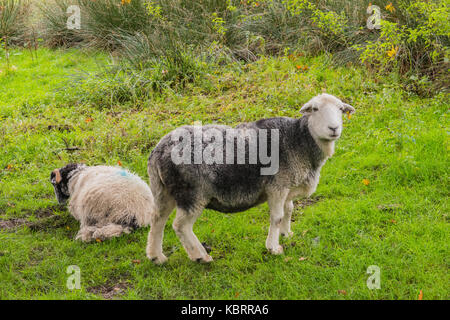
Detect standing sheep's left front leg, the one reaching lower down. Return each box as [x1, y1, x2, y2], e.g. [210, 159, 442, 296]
[266, 192, 288, 254]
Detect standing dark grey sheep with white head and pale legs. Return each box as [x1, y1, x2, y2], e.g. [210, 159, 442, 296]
[147, 94, 355, 264]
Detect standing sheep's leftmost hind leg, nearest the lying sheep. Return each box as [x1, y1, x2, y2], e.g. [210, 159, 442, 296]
[146, 200, 175, 264]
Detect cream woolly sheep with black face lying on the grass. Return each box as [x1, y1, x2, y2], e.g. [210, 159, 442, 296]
[50, 164, 153, 241]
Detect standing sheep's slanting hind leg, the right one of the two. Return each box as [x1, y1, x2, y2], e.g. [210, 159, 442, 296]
[173, 207, 213, 263]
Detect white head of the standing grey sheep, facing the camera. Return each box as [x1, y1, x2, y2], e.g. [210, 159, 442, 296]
[300, 93, 355, 142]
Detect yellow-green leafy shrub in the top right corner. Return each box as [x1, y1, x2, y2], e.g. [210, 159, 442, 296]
[357, 0, 450, 95]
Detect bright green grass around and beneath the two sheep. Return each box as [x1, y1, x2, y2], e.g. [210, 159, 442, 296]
[0, 49, 450, 299]
